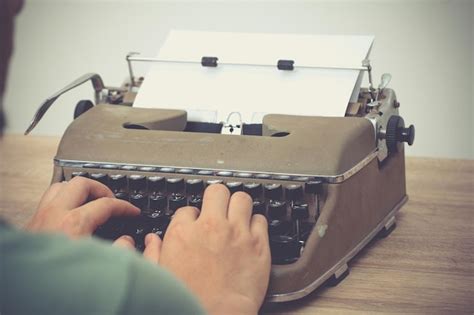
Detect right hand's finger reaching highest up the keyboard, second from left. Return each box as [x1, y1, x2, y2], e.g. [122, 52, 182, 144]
[199, 184, 230, 219]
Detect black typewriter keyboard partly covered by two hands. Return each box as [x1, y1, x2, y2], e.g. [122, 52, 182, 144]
[64, 165, 323, 264]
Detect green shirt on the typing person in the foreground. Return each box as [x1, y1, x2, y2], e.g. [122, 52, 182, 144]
[0, 222, 204, 315]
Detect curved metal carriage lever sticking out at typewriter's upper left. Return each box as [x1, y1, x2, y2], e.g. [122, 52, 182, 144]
[25, 73, 105, 135]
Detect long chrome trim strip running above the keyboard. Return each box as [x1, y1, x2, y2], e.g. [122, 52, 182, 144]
[54, 150, 377, 184]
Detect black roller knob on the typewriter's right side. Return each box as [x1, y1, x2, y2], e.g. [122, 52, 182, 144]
[385, 115, 415, 153]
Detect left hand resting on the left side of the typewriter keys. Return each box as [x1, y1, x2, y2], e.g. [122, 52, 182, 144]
[25, 176, 140, 238]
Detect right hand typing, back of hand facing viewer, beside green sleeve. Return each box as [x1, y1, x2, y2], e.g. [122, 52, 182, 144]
[159, 185, 271, 314]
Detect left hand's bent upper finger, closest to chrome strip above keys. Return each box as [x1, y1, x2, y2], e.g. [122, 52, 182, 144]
[54, 176, 114, 210]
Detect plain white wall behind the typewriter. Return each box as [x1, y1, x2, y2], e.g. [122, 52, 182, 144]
[5, 0, 474, 159]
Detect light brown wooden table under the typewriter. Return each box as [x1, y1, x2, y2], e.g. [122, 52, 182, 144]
[0, 136, 474, 314]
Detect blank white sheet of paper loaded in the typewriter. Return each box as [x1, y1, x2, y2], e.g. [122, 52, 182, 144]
[134, 31, 373, 123]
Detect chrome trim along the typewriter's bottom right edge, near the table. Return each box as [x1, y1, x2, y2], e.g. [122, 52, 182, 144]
[265, 195, 408, 302]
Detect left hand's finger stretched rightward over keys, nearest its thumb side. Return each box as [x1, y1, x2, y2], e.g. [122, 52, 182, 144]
[72, 197, 140, 234]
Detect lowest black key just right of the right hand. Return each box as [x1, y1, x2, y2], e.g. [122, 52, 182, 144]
[270, 235, 301, 265]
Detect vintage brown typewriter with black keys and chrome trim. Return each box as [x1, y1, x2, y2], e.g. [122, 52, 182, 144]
[25, 33, 414, 302]
